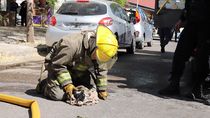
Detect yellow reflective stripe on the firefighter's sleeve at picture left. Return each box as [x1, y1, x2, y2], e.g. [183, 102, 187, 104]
[57, 71, 71, 84]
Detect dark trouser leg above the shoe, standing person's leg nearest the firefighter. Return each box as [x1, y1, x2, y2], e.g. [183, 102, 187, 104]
[171, 23, 199, 84]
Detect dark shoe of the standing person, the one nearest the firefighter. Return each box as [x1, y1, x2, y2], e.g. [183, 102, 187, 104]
[158, 84, 180, 96]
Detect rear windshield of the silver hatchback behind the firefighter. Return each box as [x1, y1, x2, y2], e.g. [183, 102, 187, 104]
[57, 2, 107, 15]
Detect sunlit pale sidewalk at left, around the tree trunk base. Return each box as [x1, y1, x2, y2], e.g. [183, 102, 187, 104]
[0, 27, 46, 70]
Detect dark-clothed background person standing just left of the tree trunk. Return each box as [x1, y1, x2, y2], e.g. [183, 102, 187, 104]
[19, 0, 27, 26]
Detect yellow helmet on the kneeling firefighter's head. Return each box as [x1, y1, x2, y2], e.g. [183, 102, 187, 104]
[96, 25, 118, 62]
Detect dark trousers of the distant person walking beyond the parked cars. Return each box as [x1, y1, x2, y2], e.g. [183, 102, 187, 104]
[158, 27, 172, 48]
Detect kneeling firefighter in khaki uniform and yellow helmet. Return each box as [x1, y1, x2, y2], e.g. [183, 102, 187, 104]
[36, 25, 118, 100]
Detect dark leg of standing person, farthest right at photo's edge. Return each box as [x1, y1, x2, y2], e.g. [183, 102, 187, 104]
[192, 28, 210, 98]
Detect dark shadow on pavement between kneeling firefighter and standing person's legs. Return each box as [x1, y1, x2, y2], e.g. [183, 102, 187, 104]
[109, 50, 194, 100]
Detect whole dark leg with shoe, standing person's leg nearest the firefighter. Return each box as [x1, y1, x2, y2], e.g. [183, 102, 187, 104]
[159, 26, 196, 95]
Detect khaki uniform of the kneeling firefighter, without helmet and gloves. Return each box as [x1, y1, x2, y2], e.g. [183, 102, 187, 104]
[38, 32, 117, 100]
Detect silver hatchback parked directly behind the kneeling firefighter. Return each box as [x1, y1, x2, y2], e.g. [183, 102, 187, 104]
[46, 0, 135, 53]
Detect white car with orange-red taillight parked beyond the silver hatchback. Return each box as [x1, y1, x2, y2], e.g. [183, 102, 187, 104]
[126, 7, 154, 49]
